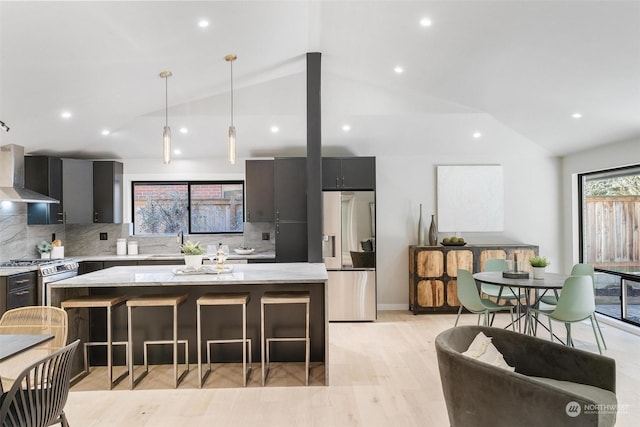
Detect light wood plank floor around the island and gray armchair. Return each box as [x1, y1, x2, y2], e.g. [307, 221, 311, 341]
[65, 311, 640, 427]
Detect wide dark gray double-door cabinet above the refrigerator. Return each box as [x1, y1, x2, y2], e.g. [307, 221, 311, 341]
[322, 157, 376, 190]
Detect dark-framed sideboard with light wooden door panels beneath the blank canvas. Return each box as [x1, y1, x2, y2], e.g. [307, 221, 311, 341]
[409, 244, 538, 314]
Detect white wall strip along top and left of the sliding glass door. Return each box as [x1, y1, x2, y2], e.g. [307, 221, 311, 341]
[561, 135, 640, 270]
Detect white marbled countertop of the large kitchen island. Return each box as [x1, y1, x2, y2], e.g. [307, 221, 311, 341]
[49, 263, 327, 288]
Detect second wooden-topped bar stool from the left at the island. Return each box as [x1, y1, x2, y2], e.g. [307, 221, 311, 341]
[127, 294, 189, 390]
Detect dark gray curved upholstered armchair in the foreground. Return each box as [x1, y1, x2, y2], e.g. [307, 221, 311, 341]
[435, 326, 617, 427]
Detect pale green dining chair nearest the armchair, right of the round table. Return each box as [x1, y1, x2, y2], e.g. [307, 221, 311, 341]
[531, 276, 602, 354]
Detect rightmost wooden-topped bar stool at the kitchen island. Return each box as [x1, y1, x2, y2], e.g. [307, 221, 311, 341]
[260, 291, 311, 386]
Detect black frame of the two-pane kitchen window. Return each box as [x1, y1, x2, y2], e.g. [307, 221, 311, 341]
[131, 180, 246, 237]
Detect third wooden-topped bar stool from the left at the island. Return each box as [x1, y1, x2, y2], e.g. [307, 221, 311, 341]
[196, 293, 253, 388]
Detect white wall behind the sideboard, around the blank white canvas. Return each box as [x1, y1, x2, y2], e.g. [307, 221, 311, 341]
[376, 150, 562, 309]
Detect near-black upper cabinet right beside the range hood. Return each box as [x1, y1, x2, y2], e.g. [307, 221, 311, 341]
[24, 156, 64, 225]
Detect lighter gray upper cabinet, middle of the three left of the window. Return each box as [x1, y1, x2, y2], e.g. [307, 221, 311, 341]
[62, 158, 93, 224]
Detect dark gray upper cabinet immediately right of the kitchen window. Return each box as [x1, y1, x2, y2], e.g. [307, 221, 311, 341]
[245, 160, 274, 222]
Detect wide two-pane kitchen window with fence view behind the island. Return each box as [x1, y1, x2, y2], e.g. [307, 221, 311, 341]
[131, 181, 244, 235]
